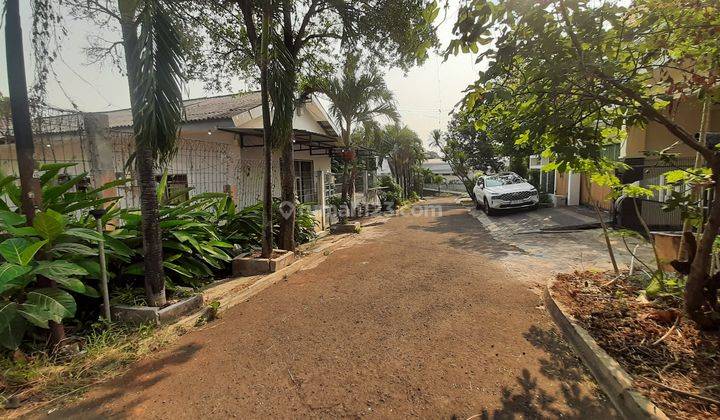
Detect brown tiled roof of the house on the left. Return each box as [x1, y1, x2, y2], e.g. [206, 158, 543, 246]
[100, 92, 261, 127]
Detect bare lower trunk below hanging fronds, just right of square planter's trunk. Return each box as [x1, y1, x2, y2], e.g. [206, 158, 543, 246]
[278, 139, 297, 251]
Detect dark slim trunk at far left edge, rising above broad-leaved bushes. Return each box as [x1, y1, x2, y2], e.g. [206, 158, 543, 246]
[5, 0, 65, 347]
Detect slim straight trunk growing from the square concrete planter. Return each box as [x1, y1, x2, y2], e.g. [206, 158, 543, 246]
[260, 6, 273, 258]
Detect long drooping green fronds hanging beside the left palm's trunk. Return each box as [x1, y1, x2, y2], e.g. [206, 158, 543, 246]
[133, 0, 184, 164]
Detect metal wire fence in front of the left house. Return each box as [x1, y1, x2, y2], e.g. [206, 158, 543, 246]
[0, 109, 341, 221]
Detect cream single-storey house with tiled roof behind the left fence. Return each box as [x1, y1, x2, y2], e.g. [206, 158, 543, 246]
[0, 92, 341, 230]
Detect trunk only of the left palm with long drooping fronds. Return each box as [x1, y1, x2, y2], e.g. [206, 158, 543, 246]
[118, 0, 166, 306]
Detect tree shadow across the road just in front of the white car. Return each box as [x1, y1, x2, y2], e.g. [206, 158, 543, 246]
[408, 205, 525, 257]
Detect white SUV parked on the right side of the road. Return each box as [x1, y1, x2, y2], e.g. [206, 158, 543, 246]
[473, 172, 540, 215]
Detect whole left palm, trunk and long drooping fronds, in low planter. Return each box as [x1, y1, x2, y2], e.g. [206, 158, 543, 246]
[118, 0, 183, 306]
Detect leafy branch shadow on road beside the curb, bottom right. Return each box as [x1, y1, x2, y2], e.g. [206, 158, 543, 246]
[462, 326, 617, 419]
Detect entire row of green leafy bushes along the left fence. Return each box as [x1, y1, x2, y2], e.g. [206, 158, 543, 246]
[0, 164, 317, 349]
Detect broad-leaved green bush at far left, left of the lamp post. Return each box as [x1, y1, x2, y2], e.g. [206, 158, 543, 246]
[0, 164, 125, 349]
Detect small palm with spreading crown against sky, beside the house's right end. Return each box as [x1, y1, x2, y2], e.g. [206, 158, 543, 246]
[308, 54, 399, 208]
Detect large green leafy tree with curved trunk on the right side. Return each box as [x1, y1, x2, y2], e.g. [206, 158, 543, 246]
[447, 0, 720, 327]
